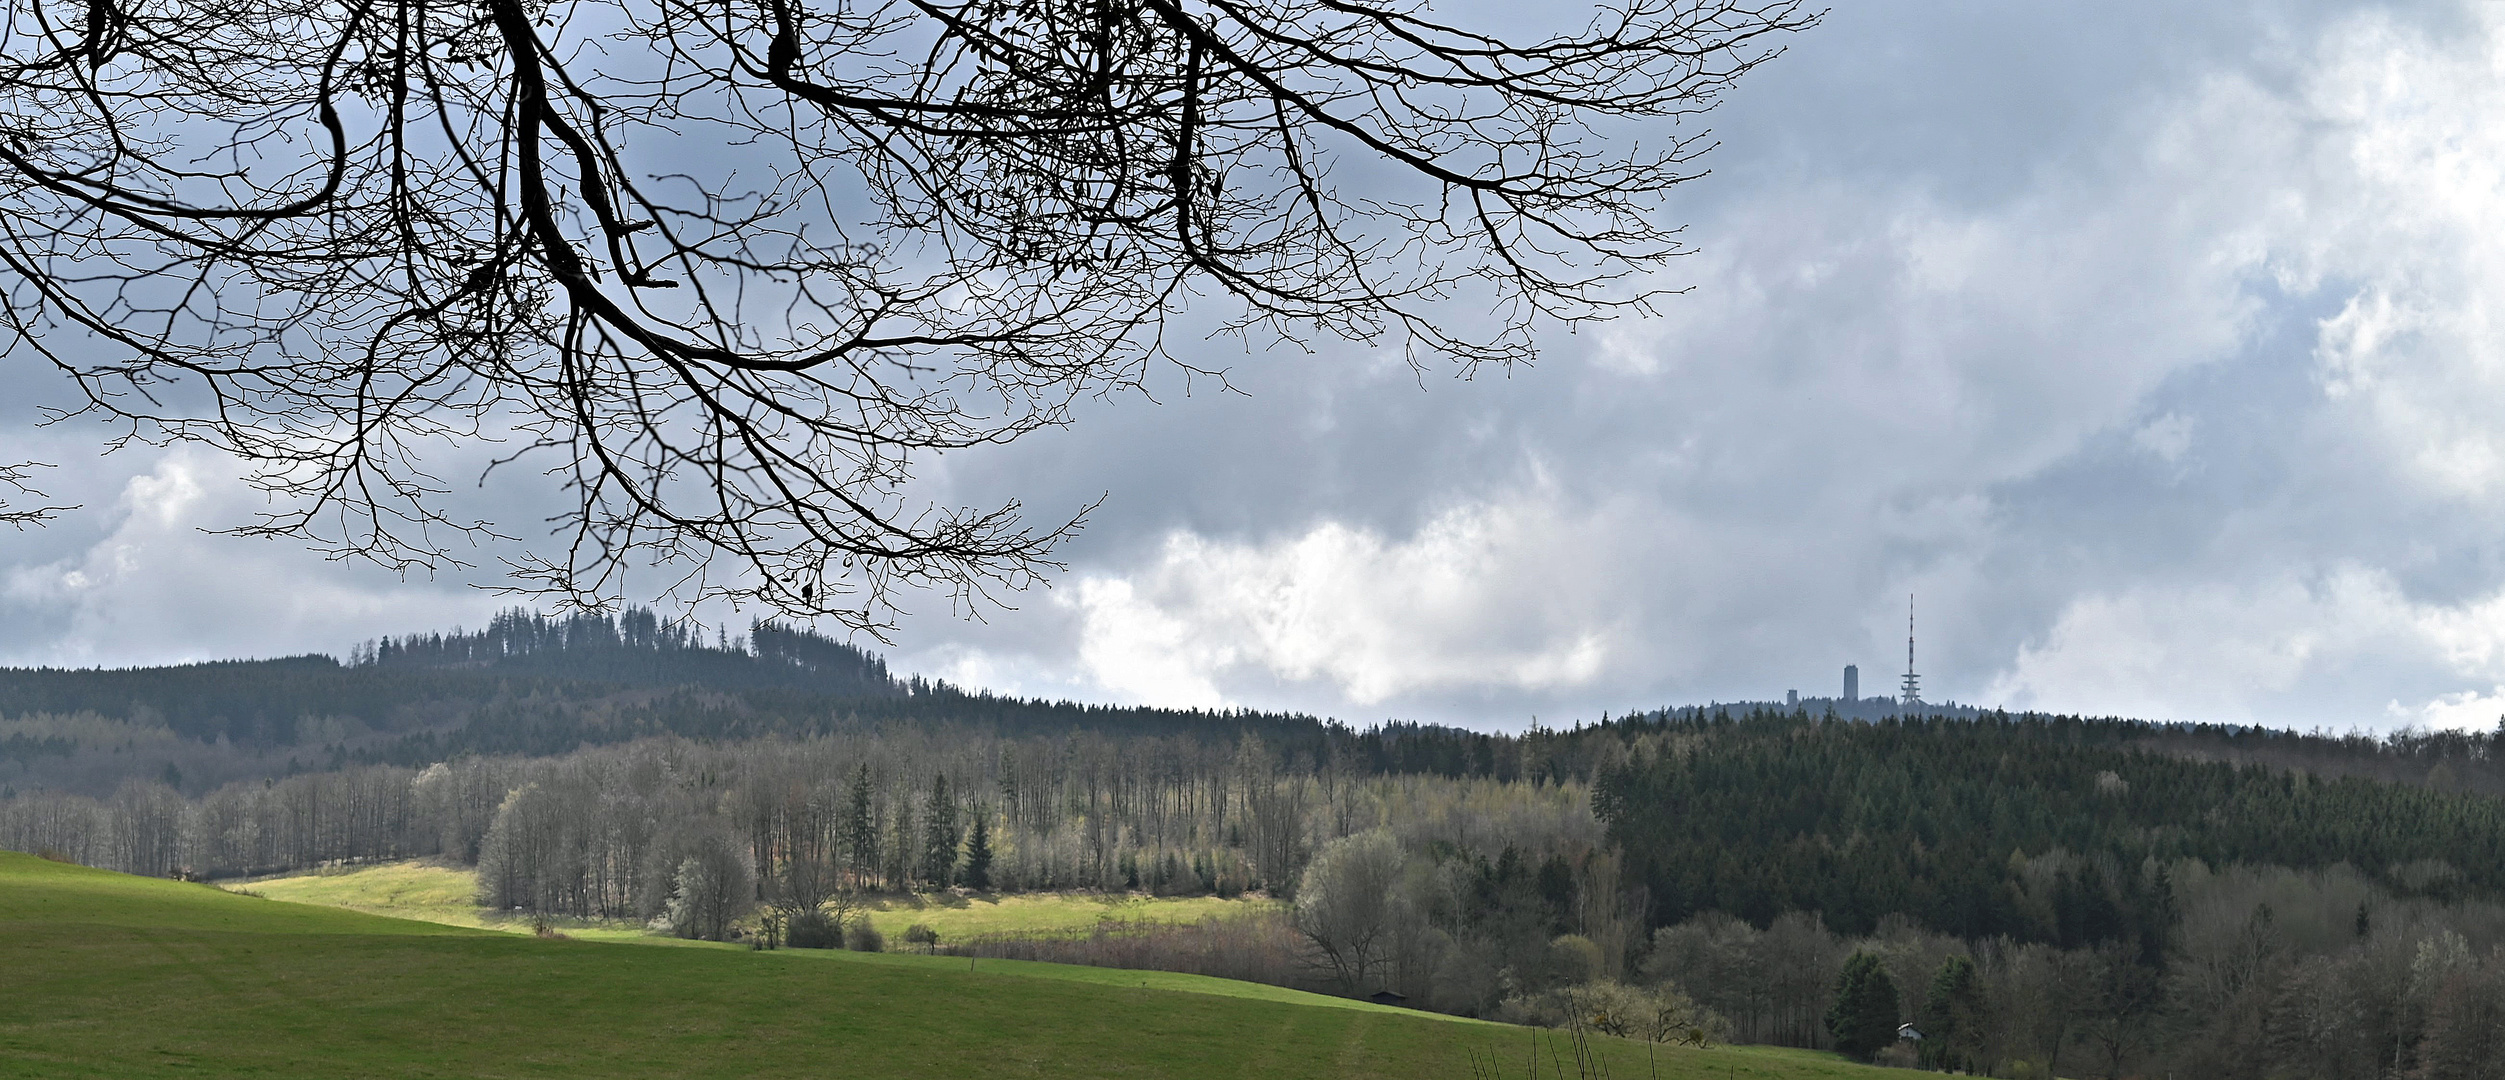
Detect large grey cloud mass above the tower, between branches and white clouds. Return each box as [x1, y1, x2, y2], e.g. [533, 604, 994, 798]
[912, 5, 2495, 724]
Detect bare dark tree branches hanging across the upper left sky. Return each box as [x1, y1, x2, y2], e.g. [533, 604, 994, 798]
[0, 0, 1816, 631]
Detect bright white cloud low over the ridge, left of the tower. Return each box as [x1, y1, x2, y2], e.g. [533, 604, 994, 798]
[1070, 496, 1613, 707]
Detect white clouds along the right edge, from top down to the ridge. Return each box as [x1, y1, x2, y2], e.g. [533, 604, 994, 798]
[1963, 5, 2505, 727]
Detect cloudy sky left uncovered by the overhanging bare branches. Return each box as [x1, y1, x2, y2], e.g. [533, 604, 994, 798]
[14, 0, 2505, 729]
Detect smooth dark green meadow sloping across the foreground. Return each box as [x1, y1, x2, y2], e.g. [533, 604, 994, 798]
[0, 852, 1886, 1080]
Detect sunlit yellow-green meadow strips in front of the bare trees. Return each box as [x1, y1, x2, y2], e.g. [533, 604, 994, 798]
[230, 859, 1268, 945]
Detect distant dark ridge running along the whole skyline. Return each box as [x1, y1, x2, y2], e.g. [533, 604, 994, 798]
[0, 609, 2505, 816]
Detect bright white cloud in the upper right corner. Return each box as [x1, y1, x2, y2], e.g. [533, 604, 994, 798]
[2277, 5, 2505, 501]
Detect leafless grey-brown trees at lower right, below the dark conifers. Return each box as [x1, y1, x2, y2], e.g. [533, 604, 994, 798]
[1638, 852, 2505, 1080]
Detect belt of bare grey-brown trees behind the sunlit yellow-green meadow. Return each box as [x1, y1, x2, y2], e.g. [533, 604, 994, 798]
[0, 727, 1601, 917]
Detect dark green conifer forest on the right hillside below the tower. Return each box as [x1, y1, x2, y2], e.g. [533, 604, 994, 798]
[1593, 712, 2505, 947]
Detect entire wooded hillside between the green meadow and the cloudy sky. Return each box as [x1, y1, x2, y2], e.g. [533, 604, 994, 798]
[0, 614, 2505, 1077]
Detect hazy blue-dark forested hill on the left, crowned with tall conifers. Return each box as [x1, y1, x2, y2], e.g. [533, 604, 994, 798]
[0, 609, 1362, 792]
